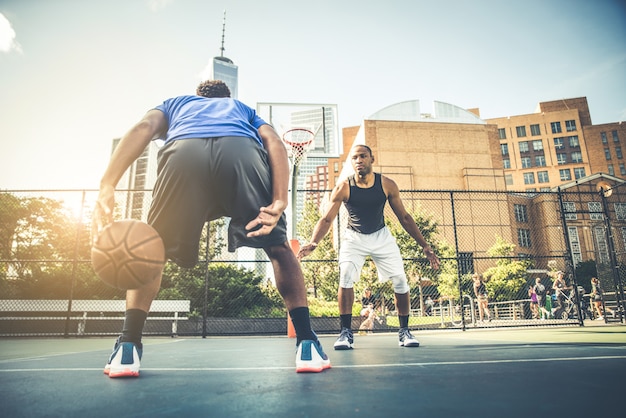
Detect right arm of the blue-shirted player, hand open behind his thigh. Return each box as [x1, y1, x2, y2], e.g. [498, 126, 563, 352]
[246, 125, 289, 237]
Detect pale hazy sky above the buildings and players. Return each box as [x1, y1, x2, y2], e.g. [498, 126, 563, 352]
[0, 0, 626, 190]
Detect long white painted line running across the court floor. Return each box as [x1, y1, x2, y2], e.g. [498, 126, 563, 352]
[0, 356, 626, 373]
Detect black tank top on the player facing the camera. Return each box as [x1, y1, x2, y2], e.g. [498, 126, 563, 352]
[345, 173, 387, 234]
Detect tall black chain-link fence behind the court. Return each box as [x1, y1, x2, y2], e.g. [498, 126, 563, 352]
[0, 187, 626, 336]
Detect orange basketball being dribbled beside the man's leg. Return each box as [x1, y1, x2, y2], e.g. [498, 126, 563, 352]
[91, 219, 165, 290]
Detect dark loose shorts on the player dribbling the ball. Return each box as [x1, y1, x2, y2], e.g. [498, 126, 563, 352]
[148, 137, 287, 267]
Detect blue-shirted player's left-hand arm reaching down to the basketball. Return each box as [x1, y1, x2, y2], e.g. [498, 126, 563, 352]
[91, 109, 167, 240]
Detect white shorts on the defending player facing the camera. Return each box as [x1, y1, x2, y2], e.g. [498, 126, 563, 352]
[339, 227, 406, 282]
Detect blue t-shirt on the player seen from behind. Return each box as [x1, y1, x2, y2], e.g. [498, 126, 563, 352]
[155, 96, 267, 146]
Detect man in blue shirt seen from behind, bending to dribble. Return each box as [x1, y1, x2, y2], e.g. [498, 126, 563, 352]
[93, 80, 330, 377]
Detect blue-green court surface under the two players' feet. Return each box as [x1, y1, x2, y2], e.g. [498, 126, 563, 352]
[0, 325, 626, 418]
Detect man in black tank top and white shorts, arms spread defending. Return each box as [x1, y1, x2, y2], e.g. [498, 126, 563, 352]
[298, 145, 439, 350]
